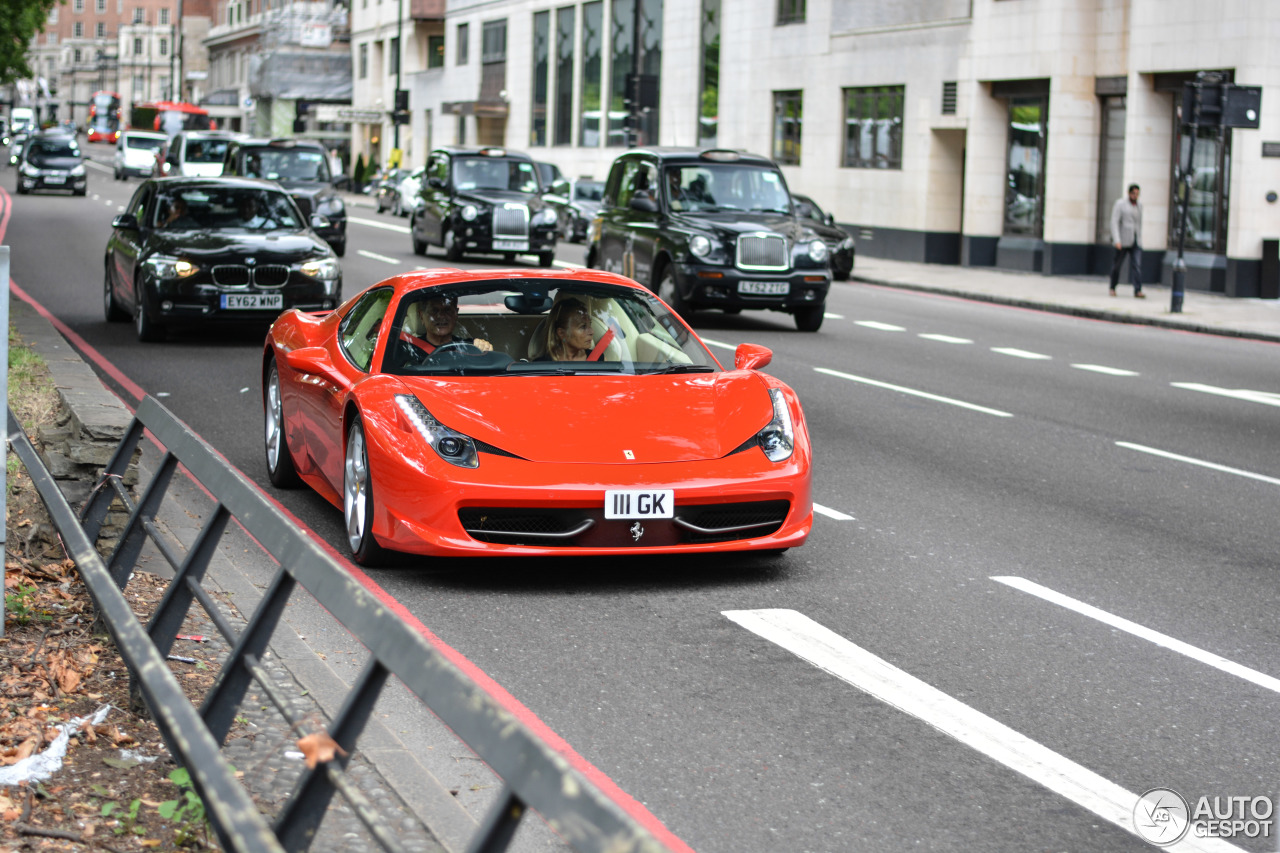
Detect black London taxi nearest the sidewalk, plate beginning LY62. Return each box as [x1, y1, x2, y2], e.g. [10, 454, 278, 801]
[586, 147, 831, 326]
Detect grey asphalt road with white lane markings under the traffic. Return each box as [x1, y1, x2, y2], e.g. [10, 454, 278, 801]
[0, 149, 1280, 853]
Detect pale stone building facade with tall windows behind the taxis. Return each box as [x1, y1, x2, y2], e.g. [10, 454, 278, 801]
[366, 0, 1280, 296]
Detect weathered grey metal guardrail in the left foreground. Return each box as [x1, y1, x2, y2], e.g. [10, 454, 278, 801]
[9, 397, 667, 853]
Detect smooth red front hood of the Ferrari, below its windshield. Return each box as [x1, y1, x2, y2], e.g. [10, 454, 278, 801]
[401, 370, 773, 465]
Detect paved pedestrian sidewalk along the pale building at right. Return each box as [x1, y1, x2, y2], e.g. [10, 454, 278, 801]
[852, 255, 1280, 343]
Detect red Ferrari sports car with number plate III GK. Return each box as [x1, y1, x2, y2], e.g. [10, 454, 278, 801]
[262, 269, 813, 564]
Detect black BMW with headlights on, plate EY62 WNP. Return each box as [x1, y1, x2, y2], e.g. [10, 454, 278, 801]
[102, 178, 342, 341]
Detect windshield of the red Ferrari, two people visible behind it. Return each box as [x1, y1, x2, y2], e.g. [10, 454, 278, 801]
[383, 278, 719, 377]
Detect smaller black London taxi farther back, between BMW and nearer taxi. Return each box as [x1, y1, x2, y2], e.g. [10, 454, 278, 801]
[410, 145, 557, 266]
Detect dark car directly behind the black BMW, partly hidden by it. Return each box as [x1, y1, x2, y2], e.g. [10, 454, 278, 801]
[223, 138, 347, 257]
